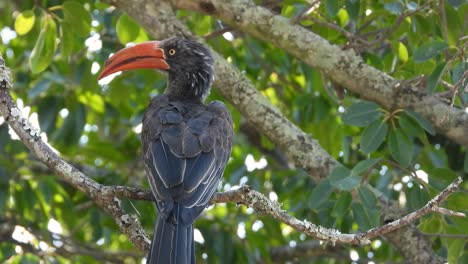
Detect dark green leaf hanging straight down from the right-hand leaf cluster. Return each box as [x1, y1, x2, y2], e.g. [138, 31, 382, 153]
[388, 129, 414, 167]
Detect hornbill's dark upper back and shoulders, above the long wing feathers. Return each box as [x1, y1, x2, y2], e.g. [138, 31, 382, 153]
[142, 95, 232, 158]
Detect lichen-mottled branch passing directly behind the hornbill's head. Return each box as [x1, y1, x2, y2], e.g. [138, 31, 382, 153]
[104, 0, 338, 180]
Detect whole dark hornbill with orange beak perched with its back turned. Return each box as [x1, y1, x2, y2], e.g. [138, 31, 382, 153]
[99, 38, 232, 264]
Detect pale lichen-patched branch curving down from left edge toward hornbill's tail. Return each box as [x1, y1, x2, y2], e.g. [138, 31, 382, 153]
[0, 54, 149, 250]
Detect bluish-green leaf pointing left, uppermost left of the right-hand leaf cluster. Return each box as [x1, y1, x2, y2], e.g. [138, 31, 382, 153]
[341, 101, 382, 127]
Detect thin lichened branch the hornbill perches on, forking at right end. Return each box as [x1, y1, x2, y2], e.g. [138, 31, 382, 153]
[105, 177, 466, 248]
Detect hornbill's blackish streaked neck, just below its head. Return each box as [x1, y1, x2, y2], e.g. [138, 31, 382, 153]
[165, 71, 211, 102]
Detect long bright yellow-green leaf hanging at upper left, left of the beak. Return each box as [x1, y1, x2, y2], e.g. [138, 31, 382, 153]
[29, 17, 57, 73]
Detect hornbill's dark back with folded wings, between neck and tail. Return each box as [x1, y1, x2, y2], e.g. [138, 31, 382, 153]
[142, 95, 232, 217]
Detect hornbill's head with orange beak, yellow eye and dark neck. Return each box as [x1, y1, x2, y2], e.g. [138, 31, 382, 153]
[98, 37, 214, 100]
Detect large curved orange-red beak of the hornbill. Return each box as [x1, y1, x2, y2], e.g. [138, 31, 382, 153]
[98, 41, 169, 80]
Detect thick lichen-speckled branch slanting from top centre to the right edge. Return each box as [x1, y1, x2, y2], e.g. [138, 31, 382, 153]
[171, 0, 468, 146]
